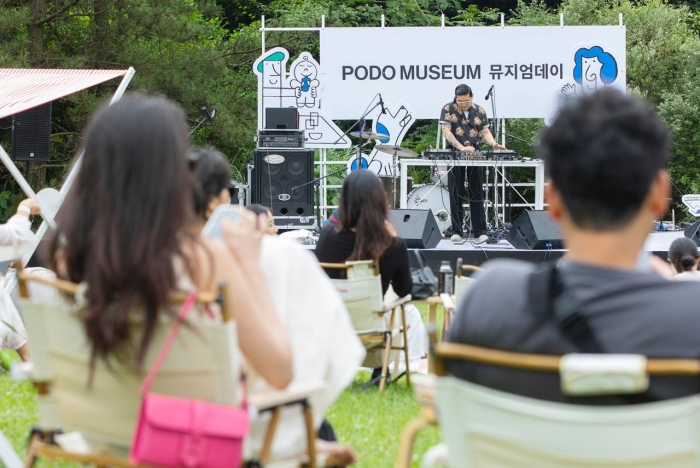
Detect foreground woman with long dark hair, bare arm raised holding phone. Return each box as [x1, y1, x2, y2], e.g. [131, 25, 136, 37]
[51, 95, 292, 388]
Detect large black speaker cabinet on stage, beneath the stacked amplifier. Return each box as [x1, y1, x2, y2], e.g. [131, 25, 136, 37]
[251, 148, 314, 216]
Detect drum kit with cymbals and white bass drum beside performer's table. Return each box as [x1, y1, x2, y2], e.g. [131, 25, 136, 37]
[350, 132, 452, 231]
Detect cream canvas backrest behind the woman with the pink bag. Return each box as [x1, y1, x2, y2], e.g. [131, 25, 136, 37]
[20, 273, 242, 453]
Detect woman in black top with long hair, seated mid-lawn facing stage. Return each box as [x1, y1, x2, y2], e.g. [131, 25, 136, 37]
[316, 170, 428, 376]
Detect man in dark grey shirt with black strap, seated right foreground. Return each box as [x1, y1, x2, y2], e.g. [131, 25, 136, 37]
[448, 90, 700, 404]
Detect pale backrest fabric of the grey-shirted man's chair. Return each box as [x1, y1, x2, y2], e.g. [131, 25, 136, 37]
[436, 377, 700, 468]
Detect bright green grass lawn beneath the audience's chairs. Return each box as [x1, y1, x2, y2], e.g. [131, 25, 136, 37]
[0, 307, 442, 468]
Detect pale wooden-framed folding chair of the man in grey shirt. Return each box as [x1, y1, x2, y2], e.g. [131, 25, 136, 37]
[399, 343, 700, 468]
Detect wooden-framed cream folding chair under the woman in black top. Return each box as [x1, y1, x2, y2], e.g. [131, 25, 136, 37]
[320, 260, 411, 391]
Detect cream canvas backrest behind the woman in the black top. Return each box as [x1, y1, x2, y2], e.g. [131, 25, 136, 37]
[321, 260, 386, 333]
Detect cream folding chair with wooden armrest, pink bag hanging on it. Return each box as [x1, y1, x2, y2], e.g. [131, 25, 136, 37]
[18, 270, 332, 468]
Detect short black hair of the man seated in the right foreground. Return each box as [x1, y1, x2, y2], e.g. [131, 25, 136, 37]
[538, 89, 671, 231]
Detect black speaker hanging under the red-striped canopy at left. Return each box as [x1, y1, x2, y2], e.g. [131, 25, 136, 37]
[11, 102, 51, 161]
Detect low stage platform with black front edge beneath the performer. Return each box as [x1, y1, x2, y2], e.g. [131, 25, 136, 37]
[308, 230, 684, 274]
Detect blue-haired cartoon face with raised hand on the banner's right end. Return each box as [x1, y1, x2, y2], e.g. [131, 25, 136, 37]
[561, 46, 618, 96]
